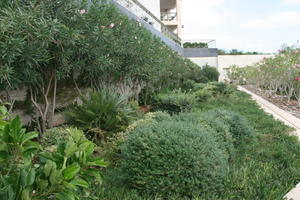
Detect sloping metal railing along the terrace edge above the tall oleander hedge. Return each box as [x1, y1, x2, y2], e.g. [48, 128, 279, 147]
[115, 0, 181, 45]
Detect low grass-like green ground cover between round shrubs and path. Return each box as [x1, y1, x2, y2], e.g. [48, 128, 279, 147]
[98, 86, 300, 200]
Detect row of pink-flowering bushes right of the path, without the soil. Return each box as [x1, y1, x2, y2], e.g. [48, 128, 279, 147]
[229, 47, 300, 106]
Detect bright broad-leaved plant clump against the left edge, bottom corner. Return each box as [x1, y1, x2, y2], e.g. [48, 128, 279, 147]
[0, 116, 40, 200]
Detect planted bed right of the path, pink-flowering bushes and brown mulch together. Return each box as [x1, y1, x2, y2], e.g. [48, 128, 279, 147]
[228, 46, 300, 118]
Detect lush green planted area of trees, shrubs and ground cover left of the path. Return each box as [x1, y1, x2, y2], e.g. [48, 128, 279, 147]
[0, 0, 300, 200]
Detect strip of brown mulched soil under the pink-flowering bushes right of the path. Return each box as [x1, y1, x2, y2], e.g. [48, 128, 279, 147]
[243, 85, 300, 119]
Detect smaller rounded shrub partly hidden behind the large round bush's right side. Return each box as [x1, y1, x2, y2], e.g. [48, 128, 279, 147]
[203, 109, 255, 145]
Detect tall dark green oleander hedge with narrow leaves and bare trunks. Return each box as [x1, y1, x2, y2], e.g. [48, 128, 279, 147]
[0, 0, 200, 131]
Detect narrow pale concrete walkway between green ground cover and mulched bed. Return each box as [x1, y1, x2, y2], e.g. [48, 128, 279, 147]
[238, 86, 300, 200]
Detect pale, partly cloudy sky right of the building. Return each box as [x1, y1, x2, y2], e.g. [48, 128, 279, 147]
[182, 0, 300, 53]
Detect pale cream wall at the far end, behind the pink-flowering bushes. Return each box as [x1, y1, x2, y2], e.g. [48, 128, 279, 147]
[218, 55, 274, 81]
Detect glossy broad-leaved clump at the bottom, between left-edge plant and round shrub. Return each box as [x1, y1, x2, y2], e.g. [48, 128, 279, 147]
[35, 129, 106, 200]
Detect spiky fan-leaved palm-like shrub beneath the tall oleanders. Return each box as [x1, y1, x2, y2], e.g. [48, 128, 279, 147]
[67, 90, 136, 137]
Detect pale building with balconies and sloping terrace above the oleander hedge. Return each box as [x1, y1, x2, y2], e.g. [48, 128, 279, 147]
[114, 0, 218, 68]
